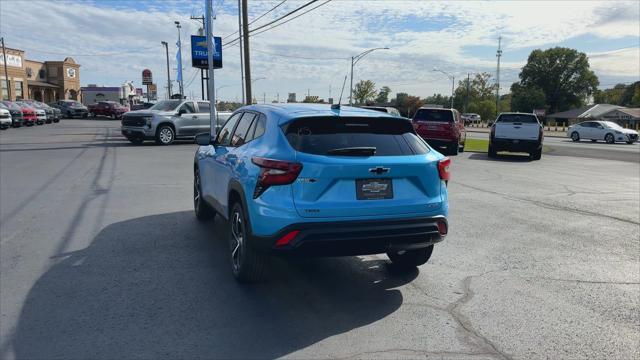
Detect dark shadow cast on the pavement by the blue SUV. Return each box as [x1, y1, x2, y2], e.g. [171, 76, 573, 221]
[10, 211, 418, 359]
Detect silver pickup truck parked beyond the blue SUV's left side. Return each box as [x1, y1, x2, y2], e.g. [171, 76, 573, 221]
[121, 99, 231, 145]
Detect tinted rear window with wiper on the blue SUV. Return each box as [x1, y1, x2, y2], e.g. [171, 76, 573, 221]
[283, 117, 429, 156]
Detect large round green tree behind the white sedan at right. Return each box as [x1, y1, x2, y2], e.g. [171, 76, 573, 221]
[520, 47, 599, 113]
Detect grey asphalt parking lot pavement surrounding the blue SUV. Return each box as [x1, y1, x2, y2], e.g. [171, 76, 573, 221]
[0, 120, 640, 359]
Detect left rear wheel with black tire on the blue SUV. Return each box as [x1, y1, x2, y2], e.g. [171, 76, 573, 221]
[228, 202, 266, 283]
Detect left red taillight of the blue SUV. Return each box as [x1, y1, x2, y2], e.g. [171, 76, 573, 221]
[251, 156, 302, 199]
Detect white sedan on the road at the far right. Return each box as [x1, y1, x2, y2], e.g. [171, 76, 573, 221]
[567, 121, 638, 144]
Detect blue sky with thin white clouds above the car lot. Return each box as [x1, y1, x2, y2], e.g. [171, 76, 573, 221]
[0, 0, 640, 102]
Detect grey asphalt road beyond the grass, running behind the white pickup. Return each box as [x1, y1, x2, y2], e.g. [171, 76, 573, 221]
[467, 131, 640, 163]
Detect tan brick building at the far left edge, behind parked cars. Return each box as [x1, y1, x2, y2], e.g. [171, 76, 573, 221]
[0, 48, 80, 102]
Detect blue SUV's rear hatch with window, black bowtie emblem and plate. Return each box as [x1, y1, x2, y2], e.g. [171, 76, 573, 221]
[283, 117, 442, 218]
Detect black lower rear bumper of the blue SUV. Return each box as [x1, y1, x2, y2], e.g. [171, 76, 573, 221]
[254, 216, 449, 257]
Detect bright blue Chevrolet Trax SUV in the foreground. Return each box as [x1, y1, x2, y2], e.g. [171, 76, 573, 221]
[193, 104, 450, 282]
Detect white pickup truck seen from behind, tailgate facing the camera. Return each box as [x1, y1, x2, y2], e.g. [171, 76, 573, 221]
[489, 113, 543, 160]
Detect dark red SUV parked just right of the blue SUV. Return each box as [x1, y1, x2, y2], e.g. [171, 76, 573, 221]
[413, 107, 467, 155]
